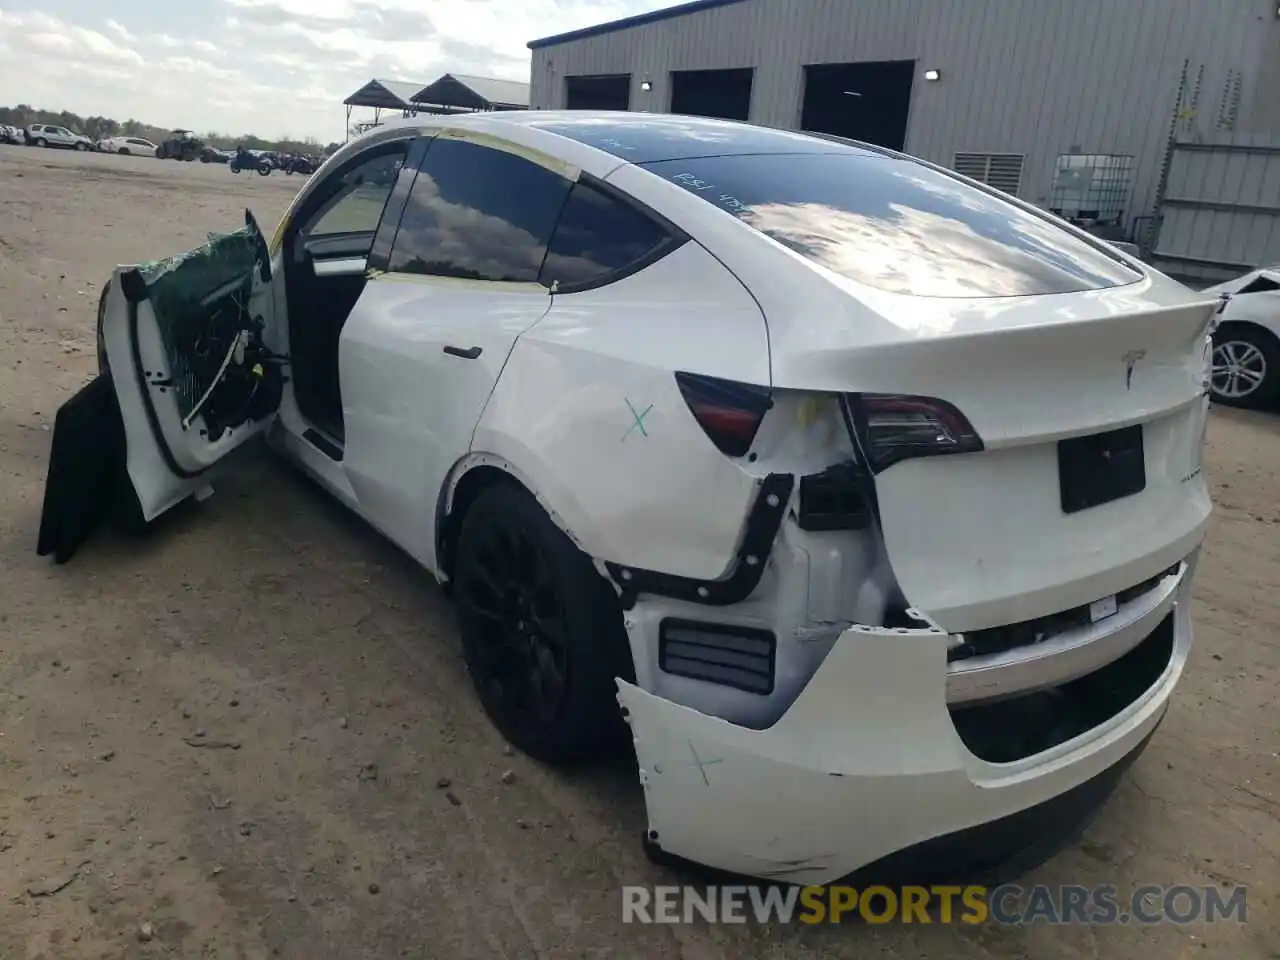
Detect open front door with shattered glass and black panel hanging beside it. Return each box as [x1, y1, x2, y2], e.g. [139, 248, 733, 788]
[37, 211, 287, 563]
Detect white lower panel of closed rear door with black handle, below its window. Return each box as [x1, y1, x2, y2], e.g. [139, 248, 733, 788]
[339, 274, 552, 568]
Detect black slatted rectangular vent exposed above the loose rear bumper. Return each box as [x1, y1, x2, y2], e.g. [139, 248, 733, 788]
[658, 620, 777, 694]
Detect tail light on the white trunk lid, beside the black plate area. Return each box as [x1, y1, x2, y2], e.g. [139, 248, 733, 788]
[846, 393, 983, 474]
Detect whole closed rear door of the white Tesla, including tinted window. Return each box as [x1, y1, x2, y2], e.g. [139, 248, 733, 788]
[339, 132, 572, 570]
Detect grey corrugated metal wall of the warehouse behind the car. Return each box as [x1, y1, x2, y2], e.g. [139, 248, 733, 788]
[531, 0, 1280, 227]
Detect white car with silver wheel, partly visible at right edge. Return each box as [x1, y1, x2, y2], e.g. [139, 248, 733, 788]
[1204, 265, 1280, 410]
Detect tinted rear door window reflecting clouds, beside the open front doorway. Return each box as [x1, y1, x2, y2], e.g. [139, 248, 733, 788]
[389, 140, 570, 283]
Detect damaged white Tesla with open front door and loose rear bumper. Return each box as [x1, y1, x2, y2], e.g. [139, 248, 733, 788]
[40, 111, 1221, 883]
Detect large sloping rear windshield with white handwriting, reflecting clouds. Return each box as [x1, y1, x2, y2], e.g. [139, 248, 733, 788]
[643, 154, 1140, 297]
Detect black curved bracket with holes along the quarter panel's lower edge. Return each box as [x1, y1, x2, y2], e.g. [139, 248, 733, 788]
[604, 474, 795, 609]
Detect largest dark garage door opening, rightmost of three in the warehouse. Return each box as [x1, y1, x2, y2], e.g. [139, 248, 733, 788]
[800, 60, 915, 150]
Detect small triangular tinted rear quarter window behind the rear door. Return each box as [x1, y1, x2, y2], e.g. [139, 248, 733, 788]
[540, 182, 672, 287]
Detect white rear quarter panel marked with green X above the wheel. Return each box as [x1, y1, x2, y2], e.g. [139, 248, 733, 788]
[475, 242, 769, 580]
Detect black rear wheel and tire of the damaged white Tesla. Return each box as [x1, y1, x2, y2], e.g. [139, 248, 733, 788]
[453, 483, 635, 763]
